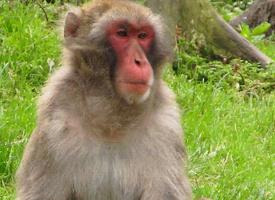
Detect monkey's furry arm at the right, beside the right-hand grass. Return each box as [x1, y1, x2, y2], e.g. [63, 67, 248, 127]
[142, 88, 192, 200]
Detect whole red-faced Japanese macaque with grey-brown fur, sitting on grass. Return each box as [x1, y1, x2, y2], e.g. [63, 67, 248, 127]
[17, 0, 191, 200]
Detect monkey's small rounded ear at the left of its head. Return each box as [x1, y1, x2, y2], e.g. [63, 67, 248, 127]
[64, 12, 80, 38]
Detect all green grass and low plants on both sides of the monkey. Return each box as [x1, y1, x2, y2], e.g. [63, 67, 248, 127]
[0, 1, 275, 200]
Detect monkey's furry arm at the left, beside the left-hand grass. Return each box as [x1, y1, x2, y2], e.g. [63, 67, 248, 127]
[16, 129, 70, 200]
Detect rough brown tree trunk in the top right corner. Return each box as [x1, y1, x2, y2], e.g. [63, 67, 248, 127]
[230, 0, 275, 35]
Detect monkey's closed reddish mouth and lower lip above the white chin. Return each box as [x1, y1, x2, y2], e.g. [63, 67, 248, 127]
[119, 81, 151, 95]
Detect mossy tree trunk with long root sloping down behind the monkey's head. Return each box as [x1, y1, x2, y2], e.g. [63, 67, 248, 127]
[145, 0, 271, 66]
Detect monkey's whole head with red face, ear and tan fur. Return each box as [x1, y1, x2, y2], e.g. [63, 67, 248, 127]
[64, 0, 172, 104]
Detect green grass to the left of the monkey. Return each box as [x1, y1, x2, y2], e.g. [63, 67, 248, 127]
[0, 1, 59, 189]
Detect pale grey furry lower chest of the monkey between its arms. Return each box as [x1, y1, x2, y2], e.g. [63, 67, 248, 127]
[67, 141, 153, 200]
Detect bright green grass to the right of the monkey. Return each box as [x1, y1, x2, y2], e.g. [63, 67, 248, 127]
[168, 70, 275, 199]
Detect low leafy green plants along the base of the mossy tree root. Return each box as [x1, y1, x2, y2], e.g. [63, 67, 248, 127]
[173, 34, 275, 96]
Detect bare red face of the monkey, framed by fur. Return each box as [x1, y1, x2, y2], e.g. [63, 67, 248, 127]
[107, 21, 155, 103]
